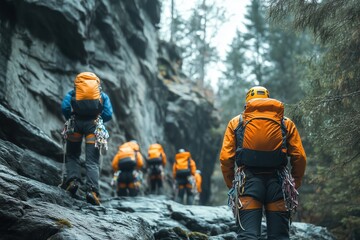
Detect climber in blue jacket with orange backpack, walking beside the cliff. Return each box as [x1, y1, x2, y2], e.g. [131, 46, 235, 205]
[61, 72, 113, 205]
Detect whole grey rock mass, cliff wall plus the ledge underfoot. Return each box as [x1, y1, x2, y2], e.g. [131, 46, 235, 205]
[0, 0, 338, 240]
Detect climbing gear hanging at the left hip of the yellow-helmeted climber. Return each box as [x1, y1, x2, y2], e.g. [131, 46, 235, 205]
[228, 167, 246, 230]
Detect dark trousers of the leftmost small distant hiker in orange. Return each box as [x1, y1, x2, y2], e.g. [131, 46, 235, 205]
[117, 170, 139, 197]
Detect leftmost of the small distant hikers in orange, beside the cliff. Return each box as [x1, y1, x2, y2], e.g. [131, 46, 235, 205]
[112, 140, 144, 196]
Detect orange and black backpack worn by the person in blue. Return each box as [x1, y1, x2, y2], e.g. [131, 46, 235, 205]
[71, 72, 103, 116]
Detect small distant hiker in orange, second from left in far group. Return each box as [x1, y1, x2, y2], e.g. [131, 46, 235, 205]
[146, 143, 166, 194]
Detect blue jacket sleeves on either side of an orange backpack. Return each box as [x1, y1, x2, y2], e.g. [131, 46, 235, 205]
[61, 90, 113, 122]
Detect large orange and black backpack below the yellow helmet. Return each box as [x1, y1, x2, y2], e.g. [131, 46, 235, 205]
[235, 98, 287, 168]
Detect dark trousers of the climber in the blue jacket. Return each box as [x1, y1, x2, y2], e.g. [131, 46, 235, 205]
[66, 119, 100, 194]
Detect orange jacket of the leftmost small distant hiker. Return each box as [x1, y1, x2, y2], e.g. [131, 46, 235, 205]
[111, 142, 144, 172]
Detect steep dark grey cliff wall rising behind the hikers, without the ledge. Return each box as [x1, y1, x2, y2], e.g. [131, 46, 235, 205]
[0, 0, 218, 203]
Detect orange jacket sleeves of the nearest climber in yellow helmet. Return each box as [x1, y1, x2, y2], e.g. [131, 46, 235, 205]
[220, 99, 306, 188]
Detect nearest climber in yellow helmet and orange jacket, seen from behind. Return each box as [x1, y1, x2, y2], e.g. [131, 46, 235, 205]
[220, 86, 306, 240]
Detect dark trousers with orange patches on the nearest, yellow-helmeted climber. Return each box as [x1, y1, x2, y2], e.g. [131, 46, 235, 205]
[237, 170, 290, 240]
